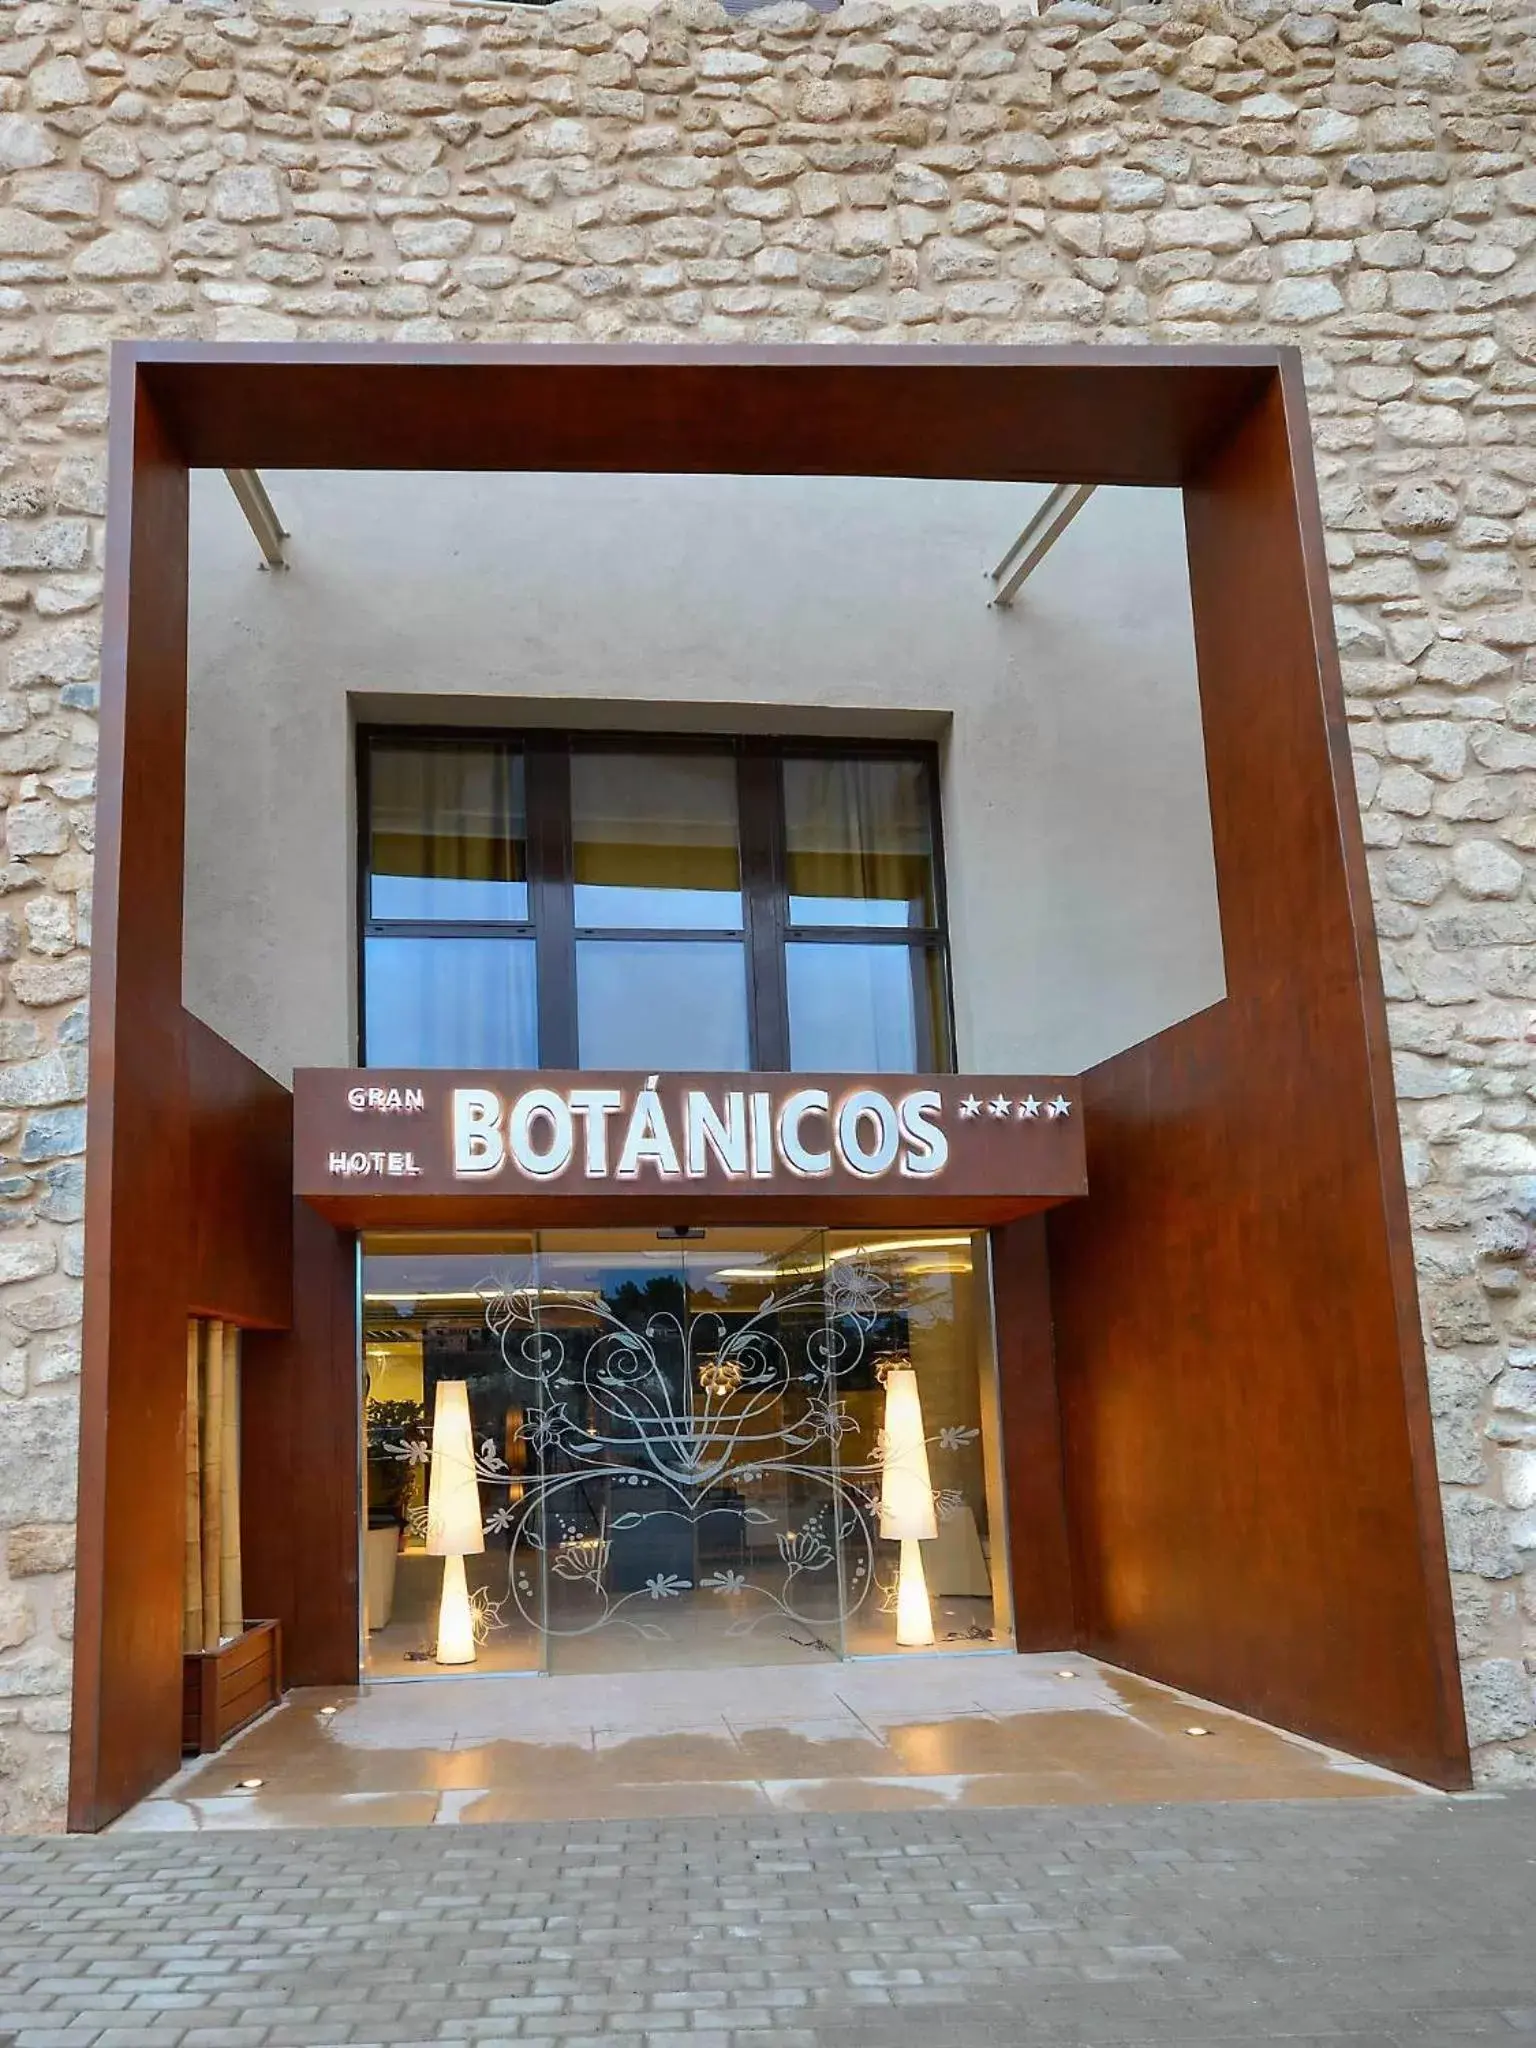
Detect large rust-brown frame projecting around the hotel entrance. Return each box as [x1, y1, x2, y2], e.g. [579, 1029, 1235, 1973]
[70, 342, 1468, 1829]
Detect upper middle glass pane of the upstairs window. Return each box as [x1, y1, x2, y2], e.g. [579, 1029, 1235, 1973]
[571, 754, 741, 932]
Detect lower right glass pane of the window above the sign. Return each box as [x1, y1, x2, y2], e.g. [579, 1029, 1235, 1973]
[784, 940, 948, 1073]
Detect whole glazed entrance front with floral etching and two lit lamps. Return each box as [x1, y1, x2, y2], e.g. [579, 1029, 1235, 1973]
[362, 1229, 1010, 1677]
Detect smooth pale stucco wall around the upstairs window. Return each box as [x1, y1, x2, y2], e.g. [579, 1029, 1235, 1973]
[184, 473, 1223, 1079]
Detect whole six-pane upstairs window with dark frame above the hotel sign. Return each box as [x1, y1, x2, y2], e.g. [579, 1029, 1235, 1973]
[362, 731, 950, 1073]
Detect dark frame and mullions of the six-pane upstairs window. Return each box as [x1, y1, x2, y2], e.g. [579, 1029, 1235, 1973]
[356, 723, 954, 1073]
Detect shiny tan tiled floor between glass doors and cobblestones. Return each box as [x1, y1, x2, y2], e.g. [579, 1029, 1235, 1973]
[117, 1655, 1421, 1829]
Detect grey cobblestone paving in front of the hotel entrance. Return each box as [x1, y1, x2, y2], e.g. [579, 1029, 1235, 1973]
[0, 1792, 1536, 2048]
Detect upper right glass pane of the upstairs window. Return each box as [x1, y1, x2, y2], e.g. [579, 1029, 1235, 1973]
[784, 758, 938, 930]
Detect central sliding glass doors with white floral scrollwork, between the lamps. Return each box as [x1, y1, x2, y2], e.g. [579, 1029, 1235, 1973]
[528, 1231, 843, 1671]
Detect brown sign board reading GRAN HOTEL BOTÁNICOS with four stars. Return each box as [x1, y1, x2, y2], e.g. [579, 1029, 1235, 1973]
[295, 1069, 1083, 1221]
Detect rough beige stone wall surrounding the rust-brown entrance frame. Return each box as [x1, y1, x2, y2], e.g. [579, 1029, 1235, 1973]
[0, 0, 1536, 1829]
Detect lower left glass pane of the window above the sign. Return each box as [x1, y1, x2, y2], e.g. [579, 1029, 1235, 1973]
[362, 938, 539, 1067]
